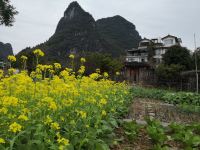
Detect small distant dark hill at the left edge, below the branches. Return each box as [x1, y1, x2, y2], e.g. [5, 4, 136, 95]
[0, 42, 13, 61]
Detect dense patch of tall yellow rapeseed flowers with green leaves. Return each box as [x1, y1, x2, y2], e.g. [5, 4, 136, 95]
[0, 50, 130, 150]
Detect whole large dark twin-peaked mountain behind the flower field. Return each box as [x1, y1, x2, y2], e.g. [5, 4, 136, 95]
[18, 2, 141, 64]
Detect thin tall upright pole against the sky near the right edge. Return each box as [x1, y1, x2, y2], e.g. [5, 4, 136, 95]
[194, 34, 199, 94]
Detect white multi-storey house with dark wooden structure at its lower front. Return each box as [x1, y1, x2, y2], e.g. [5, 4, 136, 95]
[125, 35, 182, 82]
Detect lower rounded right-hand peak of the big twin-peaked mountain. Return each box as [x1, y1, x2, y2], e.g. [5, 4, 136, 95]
[96, 15, 141, 55]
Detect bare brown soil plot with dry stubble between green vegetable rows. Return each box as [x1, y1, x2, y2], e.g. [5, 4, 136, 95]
[127, 98, 200, 123]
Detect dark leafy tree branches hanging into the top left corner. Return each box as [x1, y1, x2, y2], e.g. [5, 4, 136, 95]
[0, 0, 18, 26]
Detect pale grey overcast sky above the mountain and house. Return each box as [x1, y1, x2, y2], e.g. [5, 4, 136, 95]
[0, 0, 200, 53]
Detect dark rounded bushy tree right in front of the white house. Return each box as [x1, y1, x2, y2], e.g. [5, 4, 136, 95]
[163, 46, 192, 70]
